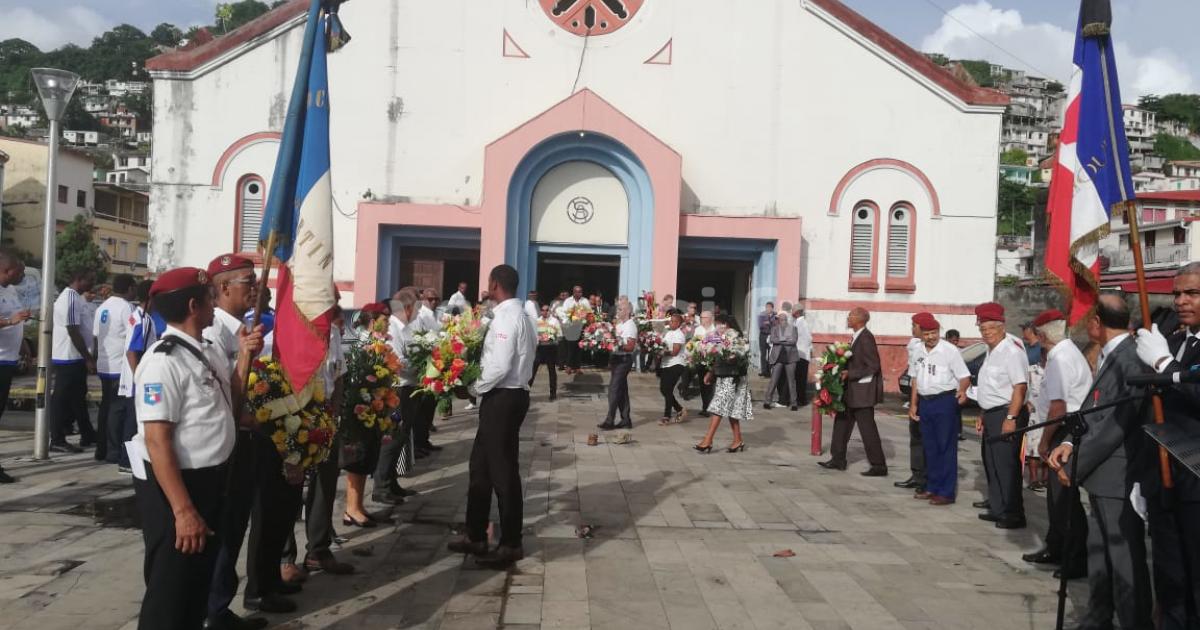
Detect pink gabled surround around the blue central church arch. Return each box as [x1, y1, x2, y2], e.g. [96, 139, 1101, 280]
[480, 89, 683, 293]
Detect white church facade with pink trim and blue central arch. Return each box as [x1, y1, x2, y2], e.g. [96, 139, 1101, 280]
[146, 0, 1007, 383]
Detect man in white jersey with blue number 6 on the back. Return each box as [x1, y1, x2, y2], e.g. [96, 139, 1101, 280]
[92, 274, 133, 463]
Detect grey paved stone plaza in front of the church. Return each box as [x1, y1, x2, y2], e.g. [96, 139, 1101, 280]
[0, 373, 1086, 630]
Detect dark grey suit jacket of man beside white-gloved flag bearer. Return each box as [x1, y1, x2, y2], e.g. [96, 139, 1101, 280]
[1068, 335, 1146, 498]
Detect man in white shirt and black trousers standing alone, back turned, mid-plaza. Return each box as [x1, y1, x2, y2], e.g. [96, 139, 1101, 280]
[448, 265, 538, 569]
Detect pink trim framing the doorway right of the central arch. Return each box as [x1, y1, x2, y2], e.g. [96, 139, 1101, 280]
[681, 215, 803, 295]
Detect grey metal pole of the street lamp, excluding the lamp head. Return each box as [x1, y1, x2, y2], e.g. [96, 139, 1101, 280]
[34, 118, 60, 460]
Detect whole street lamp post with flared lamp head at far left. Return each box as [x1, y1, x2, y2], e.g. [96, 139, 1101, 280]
[31, 68, 79, 460]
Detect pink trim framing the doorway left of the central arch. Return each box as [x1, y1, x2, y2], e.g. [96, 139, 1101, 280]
[353, 202, 482, 306]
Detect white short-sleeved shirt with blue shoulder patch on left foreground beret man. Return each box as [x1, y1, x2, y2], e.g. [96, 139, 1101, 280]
[133, 325, 236, 469]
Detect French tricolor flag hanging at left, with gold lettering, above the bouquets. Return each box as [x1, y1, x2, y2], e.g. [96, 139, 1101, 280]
[259, 0, 341, 391]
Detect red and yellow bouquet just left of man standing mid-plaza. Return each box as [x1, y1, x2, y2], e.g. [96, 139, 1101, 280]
[408, 311, 485, 413]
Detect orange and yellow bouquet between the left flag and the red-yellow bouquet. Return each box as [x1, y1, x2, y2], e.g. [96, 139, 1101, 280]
[342, 320, 401, 439]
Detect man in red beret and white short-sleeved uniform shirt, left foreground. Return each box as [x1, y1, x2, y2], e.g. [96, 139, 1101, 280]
[133, 268, 262, 630]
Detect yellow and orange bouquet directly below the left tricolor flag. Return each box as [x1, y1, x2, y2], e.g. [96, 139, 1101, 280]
[246, 359, 337, 475]
